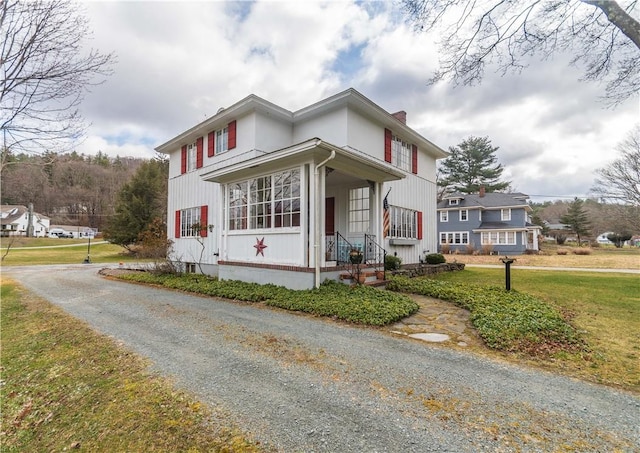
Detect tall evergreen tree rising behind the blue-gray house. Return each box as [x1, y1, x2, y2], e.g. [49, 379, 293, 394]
[438, 137, 511, 193]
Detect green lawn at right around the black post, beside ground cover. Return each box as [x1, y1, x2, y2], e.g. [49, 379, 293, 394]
[435, 268, 640, 392]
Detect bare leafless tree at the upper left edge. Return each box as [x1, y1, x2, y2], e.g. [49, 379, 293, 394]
[0, 0, 114, 168]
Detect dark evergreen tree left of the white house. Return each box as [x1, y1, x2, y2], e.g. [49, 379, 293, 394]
[104, 159, 169, 249]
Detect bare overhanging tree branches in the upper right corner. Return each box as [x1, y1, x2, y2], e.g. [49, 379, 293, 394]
[402, 0, 640, 105]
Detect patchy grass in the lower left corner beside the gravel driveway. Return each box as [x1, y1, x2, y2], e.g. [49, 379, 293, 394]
[0, 280, 259, 452]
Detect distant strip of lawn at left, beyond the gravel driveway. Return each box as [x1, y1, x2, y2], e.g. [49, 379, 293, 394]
[0, 238, 140, 266]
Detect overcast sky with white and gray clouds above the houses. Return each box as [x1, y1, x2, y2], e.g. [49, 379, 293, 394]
[78, 1, 640, 201]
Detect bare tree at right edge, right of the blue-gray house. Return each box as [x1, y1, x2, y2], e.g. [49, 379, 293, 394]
[591, 126, 640, 208]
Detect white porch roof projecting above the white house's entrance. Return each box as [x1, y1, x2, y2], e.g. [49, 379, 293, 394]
[201, 138, 406, 184]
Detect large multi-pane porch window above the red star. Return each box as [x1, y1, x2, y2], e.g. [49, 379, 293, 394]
[227, 169, 300, 230]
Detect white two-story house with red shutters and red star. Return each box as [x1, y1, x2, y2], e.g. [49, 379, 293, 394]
[156, 89, 447, 288]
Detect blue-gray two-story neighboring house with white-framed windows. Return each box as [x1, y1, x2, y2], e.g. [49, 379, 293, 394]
[437, 189, 542, 255]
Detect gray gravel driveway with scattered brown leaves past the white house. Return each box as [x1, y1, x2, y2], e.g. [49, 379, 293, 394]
[3, 265, 640, 452]
